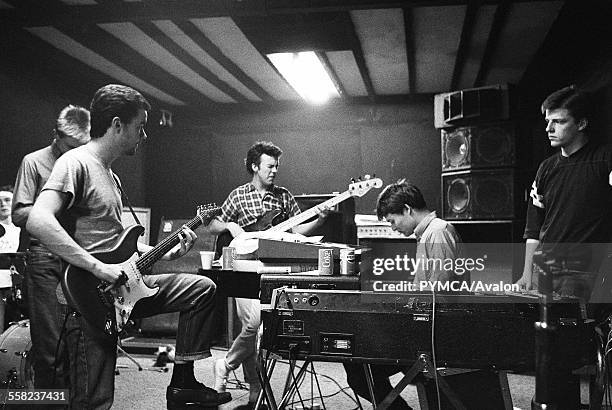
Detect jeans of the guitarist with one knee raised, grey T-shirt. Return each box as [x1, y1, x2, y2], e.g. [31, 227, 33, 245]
[68, 273, 216, 409]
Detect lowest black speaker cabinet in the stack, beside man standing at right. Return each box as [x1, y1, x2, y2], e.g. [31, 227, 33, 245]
[442, 168, 520, 220]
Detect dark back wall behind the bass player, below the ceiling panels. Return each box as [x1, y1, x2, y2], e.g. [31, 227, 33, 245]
[146, 96, 440, 239]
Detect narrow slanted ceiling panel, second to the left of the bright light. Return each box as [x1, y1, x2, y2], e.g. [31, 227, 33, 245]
[153, 20, 261, 102]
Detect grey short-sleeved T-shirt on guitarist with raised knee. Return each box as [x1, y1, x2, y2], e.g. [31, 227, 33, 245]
[43, 145, 123, 252]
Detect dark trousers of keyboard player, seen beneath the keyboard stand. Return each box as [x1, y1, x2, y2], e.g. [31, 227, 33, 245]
[344, 363, 410, 410]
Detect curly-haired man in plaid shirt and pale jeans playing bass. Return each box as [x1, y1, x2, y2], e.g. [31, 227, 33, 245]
[210, 141, 327, 410]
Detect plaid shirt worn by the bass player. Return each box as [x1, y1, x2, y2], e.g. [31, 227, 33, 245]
[221, 182, 300, 227]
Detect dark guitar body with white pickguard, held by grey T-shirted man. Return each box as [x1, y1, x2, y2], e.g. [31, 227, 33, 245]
[62, 225, 158, 337]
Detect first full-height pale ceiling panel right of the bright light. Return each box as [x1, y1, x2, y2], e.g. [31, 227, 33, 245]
[351, 9, 409, 95]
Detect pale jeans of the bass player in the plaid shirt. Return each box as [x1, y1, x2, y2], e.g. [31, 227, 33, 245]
[225, 298, 261, 390]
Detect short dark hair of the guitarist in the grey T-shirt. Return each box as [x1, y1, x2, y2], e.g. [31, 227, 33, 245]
[89, 84, 151, 138]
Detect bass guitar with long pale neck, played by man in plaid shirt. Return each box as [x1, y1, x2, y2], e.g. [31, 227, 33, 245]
[215, 176, 382, 253]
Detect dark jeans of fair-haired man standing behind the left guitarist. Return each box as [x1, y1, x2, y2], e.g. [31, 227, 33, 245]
[25, 245, 69, 389]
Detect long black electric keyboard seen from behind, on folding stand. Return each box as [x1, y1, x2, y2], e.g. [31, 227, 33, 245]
[262, 289, 595, 370]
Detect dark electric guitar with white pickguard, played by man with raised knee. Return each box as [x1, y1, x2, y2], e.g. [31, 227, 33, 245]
[62, 205, 221, 337]
